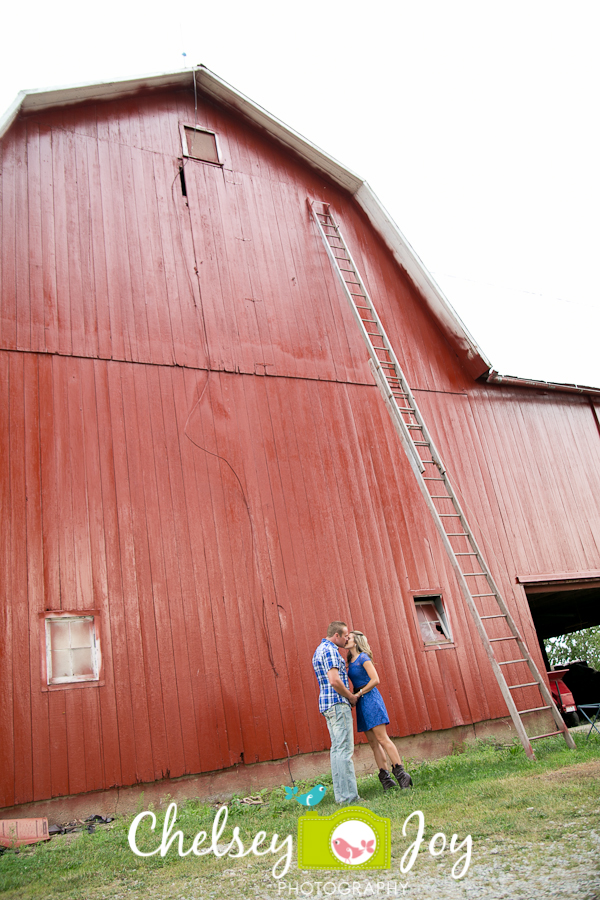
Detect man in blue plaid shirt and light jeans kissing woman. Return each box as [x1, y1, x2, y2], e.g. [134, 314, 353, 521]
[313, 622, 360, 803]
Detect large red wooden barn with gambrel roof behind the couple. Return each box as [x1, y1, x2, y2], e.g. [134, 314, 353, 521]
[0, 68, 600, 808]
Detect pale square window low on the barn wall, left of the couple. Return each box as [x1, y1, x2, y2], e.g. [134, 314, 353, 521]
[44, 613, 100, 685]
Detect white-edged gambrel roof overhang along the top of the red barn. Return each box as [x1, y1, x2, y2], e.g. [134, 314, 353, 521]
[0, 66, 587, 393]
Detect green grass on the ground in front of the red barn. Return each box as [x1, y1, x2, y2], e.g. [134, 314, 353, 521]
[0, 735, 600, 900]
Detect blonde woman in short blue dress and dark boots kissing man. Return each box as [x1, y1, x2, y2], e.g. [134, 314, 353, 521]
[346, 631, 412, 791]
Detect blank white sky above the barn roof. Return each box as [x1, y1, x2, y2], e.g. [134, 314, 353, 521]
[0, 0, 600, 387]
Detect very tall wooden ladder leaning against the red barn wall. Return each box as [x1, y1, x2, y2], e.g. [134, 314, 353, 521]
[309, 202, 575, 759]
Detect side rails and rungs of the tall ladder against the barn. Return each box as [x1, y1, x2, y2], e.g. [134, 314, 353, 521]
[309, 201, 575, 759]
